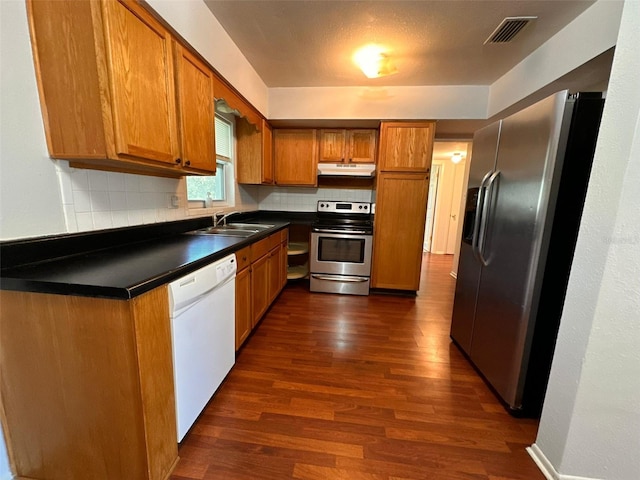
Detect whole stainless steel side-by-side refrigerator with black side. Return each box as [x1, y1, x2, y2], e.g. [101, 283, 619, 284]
[451, 91, 604, 416]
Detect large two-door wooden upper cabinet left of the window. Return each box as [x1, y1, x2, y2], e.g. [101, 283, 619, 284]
[27, 0, 215, 177]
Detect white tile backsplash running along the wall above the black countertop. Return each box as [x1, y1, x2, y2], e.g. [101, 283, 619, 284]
[57, 161, 373, 232]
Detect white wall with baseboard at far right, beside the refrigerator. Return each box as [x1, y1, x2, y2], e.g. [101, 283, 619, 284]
[532, 0, 640, 480]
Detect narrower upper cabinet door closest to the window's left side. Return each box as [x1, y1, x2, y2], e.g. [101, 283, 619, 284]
[174, 43, 216, 175]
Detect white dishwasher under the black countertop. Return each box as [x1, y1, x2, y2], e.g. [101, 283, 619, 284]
[169, 255, 236, 442]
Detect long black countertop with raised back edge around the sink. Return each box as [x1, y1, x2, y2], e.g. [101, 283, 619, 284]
[0, 212, 316, 299]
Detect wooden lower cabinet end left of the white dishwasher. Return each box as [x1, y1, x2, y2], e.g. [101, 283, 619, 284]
[0, 286, 178, 480]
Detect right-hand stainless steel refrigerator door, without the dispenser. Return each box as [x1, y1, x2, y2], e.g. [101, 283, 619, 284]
[471, 92, 570, 409]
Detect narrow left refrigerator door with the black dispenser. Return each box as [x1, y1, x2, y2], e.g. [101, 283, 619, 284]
[451, 122, 500, 355]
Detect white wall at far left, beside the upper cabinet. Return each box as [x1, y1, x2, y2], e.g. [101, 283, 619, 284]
[0, 0, 65, 238]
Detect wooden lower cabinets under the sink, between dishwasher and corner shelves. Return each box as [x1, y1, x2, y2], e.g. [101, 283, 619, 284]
[236, 229, 288, 351]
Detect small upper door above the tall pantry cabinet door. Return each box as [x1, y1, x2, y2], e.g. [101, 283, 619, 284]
[378, 121, 435, 173]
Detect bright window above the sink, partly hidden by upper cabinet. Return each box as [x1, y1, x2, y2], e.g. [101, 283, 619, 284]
[186, 113, 234, 208]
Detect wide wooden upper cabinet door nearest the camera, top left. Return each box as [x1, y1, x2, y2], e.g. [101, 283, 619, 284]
[103, 0, 178, 163]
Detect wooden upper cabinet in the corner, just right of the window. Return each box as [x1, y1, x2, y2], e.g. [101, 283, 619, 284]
[236, 117, 273, 185]
